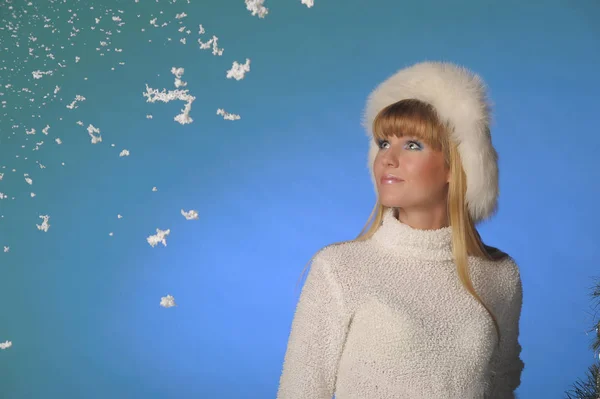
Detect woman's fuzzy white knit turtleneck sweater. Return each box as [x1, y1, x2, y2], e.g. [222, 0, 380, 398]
[277, 210, 524, 399]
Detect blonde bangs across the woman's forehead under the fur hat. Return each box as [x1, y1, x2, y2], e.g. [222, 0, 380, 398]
[373, 99, 448, 159]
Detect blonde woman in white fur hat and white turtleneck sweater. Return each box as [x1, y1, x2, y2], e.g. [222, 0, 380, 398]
[277, 62, 524, 399]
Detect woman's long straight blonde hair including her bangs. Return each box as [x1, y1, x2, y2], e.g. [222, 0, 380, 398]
[296, 99, 507, 344]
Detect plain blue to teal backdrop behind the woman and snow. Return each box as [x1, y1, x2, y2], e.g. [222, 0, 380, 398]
[0, 0, 600, 399]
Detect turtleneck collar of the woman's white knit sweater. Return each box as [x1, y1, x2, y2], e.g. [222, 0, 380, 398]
[373, 208, 453, 260]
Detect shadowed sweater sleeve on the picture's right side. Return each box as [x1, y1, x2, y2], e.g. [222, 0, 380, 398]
[486, 271, 525, 399]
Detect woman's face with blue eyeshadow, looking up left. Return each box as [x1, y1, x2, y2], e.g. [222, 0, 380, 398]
[373, 136, 450, 212]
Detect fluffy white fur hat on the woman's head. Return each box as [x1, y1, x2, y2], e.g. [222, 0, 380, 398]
[363, 62, 499, 223]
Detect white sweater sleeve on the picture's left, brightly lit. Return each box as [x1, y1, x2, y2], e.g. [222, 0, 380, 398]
[277, 255, 349, 399]
